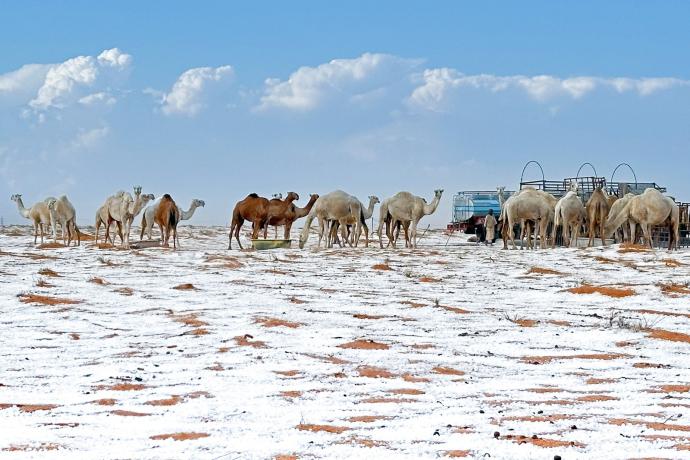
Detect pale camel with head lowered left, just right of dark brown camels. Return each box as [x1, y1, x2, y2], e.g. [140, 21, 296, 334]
[299, 190, 362, 249]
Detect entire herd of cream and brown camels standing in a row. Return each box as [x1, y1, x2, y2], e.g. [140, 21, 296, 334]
[11, 182, 679, 250]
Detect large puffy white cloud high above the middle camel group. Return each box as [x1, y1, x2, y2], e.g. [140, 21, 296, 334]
[258, 53, 420, 111]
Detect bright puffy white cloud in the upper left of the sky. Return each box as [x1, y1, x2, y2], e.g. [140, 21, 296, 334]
[29, 48, 132, 111]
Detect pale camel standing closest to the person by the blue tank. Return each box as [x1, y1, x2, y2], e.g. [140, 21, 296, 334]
[501, 187, 557, 249]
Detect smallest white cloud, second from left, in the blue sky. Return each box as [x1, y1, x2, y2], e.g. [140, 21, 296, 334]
[162, 65, 233, 116]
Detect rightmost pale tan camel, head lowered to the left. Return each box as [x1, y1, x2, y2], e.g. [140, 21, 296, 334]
[602, 188, 680, 251]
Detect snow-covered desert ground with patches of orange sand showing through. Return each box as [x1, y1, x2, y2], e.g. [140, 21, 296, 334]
[0, 227, 690, 459]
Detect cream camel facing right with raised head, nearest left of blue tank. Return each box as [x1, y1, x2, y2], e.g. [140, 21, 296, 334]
[378, 189, 443, 248]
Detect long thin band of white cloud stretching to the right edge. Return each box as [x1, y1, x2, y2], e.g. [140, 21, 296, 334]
[408, 68, 690, 111]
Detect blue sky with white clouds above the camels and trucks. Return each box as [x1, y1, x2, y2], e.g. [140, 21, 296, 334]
[0, 1, 690, 224]
